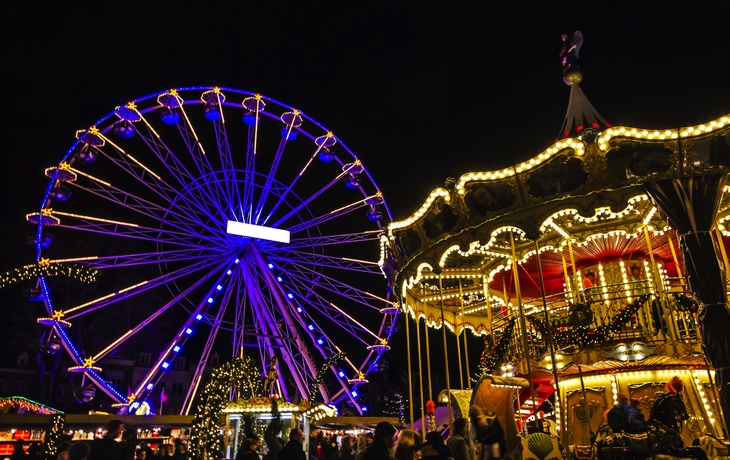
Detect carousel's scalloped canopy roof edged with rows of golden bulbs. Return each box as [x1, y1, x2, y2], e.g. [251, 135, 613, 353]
[382, 107, 730, 333]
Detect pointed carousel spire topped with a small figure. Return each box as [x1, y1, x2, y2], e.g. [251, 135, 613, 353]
[558, 30, 611, 139]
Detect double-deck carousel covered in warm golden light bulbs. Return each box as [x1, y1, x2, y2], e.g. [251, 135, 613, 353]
[382, 51, 730, 460]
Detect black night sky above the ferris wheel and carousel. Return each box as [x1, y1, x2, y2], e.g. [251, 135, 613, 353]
[0, 1, 730, 402]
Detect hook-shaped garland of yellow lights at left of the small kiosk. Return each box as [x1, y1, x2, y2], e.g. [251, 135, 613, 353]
[188, 356, 263, 459]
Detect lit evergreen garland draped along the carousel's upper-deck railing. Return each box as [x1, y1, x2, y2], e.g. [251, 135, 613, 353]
[479, 295, 649, 374]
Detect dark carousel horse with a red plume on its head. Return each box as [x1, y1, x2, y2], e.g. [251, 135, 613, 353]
[596, 377, 707, 460]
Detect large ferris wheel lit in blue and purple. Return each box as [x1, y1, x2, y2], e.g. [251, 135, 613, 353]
[27, 87, 398, 414]
